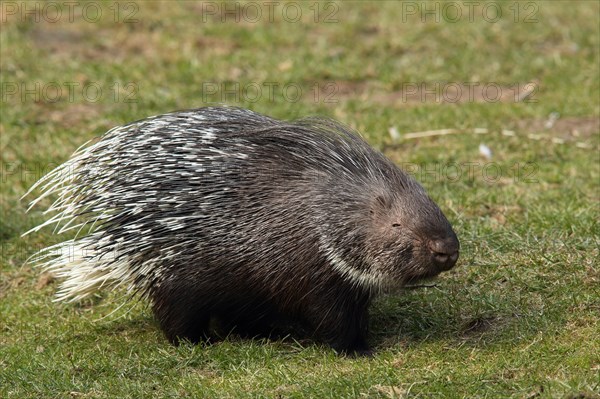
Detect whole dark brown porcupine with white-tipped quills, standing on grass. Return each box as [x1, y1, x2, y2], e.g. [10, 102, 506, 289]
[21, 107, 459, 352]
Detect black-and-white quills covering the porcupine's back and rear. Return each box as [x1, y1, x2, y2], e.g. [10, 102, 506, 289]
[25, 108, 392, 300]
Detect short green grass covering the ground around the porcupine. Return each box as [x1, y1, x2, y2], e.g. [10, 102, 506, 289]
[0, 1, 600, 398]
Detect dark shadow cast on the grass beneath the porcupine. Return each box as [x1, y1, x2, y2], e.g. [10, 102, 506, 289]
[48, 282, 526, 354]
